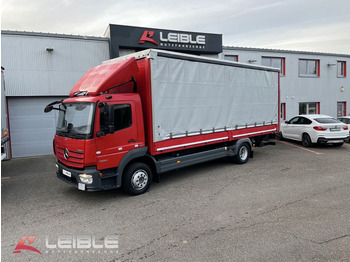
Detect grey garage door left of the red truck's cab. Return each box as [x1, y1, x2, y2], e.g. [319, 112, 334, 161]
[8, 97, 62, 158]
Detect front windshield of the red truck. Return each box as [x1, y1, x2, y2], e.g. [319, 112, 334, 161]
[56, 103, 95, 139]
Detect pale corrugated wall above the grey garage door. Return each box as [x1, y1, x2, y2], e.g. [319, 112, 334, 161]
[1, 34, 109, 96]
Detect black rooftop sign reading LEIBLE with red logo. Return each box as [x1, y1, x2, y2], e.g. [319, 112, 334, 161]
[105, 25, 222, 58]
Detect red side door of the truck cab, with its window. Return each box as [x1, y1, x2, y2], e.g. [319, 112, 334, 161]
[96, 101, 138, 170]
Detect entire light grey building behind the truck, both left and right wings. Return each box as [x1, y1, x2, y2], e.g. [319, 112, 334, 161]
[1, 27, 350, 158]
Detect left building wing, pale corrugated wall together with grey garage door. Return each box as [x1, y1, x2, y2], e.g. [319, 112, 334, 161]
[1, 31, 109, 158]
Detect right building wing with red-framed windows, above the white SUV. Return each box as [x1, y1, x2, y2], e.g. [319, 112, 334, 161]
[219, 47, 350, 120]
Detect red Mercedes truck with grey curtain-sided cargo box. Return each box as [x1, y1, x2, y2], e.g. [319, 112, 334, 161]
[45, 49, 280, 195]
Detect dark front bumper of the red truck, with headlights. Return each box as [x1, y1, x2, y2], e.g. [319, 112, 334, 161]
[56, 159, 119, 191]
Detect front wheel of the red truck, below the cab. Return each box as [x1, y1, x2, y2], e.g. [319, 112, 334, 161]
[122, 162, 152, 195]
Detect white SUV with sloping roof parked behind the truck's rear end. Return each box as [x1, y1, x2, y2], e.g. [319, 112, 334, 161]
[280, 115, 349, 147]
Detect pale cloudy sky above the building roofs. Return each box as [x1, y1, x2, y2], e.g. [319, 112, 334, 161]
[1, 0, 350, 54]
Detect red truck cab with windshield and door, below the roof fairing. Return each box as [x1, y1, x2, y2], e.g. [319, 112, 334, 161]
[54, 94, 145, 191]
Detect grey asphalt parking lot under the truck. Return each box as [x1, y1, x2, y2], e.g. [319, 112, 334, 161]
[1, 141, 350, 261]
